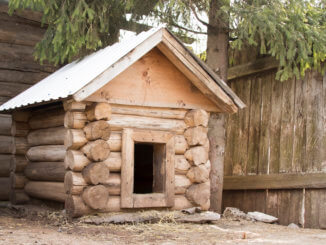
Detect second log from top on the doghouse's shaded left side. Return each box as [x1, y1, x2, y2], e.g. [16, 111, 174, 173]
[27, 127, 67, 146]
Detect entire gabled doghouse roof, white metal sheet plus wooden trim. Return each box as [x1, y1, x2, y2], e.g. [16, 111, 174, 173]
[0, 28, 245, 113]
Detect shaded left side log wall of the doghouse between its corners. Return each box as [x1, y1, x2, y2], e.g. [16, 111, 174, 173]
[21, 103, 66, 202]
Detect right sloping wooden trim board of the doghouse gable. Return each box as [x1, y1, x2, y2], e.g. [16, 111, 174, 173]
[158, 30, 238, 113]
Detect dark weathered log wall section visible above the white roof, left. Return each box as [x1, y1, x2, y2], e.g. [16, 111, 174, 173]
[0, 7, 54, 107]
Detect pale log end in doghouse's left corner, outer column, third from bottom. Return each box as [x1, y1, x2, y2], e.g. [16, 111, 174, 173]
[65, 150, 91, 172]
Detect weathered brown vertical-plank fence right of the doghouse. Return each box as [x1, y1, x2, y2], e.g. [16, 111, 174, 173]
[223, 70, 326, 228]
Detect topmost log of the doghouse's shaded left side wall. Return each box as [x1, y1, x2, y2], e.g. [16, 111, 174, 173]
[28, 108, 65, 129]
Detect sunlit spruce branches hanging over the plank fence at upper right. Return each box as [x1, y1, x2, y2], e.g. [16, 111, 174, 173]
[226, 0, 326, 81]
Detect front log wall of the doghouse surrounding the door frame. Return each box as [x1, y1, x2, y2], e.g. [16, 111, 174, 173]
[64, 101, 210, 217]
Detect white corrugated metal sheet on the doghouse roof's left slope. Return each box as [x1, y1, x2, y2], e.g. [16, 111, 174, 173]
[0, 27, 162, 111]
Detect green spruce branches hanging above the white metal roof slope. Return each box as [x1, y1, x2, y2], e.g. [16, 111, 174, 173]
[9, 0, 156, 64]
